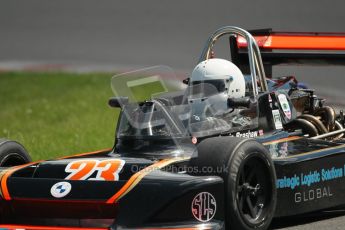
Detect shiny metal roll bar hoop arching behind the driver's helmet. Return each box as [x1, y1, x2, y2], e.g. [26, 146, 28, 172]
[199, 26, 268, 98]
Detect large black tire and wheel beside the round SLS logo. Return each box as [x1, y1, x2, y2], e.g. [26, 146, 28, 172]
[190, 137, 277, 230]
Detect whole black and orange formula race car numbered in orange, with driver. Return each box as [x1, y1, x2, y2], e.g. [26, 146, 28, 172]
[0, 26, 345, 230]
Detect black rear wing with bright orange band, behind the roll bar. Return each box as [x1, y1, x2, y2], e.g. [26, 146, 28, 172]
[230, 29, 345, 75]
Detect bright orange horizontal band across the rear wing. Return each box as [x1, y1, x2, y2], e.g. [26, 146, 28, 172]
[237, 34, 345, 50]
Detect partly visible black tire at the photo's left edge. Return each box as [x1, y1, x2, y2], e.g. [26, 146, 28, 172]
[0, 139, 31, 167]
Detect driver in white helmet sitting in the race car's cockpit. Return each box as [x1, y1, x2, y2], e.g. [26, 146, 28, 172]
[189, 58, 251, 130]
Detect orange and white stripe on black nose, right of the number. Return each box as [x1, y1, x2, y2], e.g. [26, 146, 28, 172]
[107, 157, 189, 204]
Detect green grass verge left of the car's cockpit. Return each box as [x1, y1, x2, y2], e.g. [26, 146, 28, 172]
[0, 72, 118, 160]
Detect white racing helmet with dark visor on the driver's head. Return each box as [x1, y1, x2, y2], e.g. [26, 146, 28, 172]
[190, 58, 246, 98]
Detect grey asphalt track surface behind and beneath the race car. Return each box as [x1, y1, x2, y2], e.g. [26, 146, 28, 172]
[0, 0, 345, 230]
